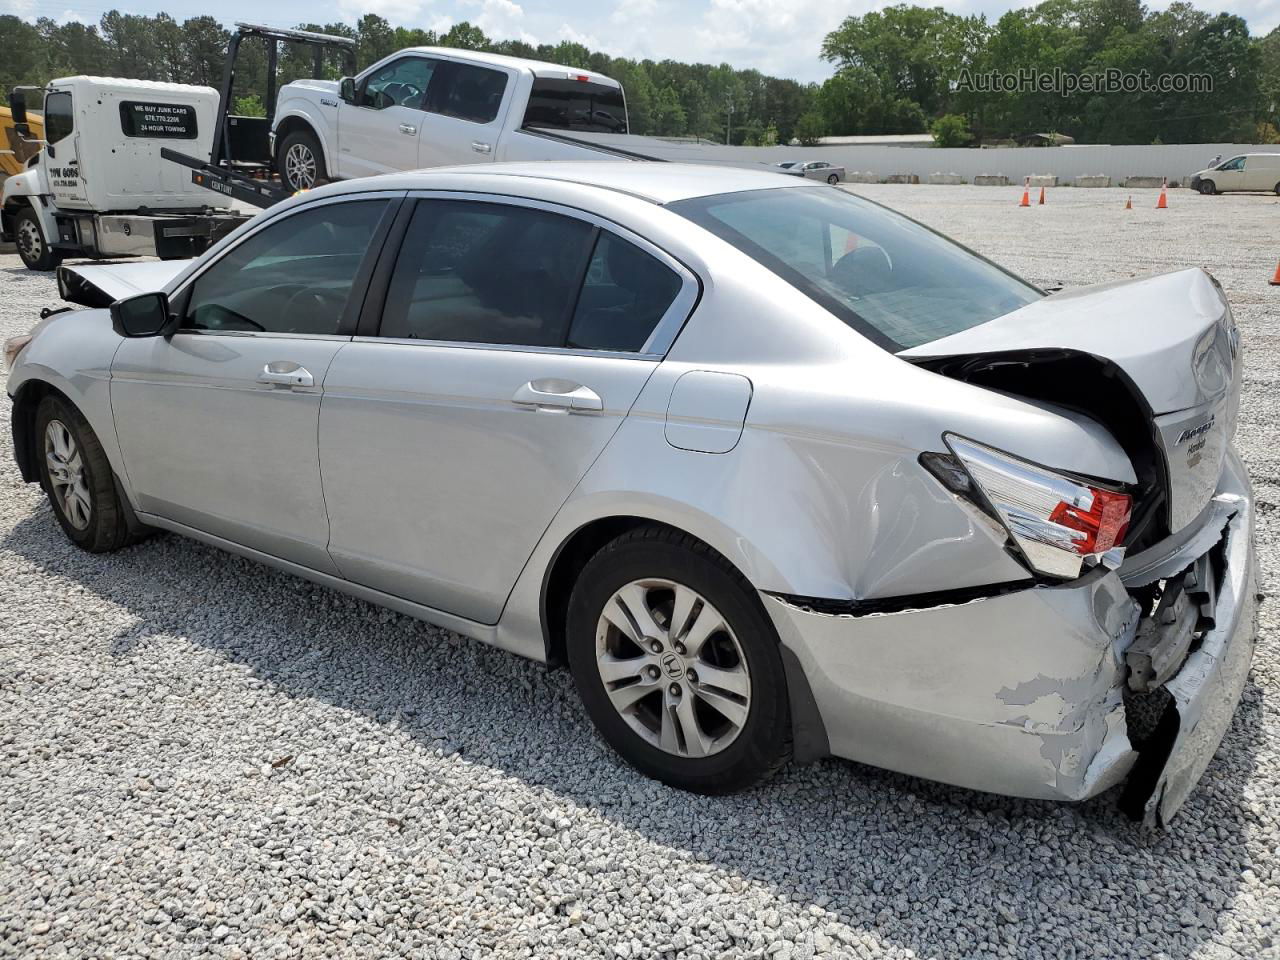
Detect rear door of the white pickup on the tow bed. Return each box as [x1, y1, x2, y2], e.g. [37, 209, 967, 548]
[417, 60, 516, 166]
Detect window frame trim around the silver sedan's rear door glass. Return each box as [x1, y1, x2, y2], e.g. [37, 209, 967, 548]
[355, 189, 703, 362]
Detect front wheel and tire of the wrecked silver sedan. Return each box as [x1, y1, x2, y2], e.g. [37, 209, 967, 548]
[35, 396, 141, 553]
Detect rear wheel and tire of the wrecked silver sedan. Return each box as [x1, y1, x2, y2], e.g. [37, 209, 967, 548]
[567, 526, 791, 794]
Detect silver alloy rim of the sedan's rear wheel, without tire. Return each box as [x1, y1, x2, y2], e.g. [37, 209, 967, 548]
[595, 579, 751, 758]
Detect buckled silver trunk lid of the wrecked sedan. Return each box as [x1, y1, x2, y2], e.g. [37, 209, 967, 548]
[900, 269, 1240, 532]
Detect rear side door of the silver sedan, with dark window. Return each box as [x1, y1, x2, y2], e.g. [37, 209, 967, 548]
[320, 197, 698, 623]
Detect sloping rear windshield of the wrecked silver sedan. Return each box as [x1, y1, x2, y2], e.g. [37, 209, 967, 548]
[671, 187, 1043, 351]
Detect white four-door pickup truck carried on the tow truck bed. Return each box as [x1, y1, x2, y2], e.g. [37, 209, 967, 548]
[271, 47, 628, 191]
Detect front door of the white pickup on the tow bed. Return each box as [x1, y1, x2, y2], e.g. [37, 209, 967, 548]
[337, 54, 440, 178]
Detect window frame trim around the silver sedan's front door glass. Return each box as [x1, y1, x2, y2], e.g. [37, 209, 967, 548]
[169, 191, 401, 340]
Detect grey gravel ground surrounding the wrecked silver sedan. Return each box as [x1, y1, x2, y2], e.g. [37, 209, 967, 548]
[0, 186, 1280, 960]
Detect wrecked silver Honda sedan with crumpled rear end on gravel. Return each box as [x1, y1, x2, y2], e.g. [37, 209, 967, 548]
[6, 163, 1256, 823]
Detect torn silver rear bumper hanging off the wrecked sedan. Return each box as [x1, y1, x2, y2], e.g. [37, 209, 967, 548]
[764, 452, 1257, 824]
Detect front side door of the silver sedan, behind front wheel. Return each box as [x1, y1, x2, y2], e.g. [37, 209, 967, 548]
[110, 195, 399, 573]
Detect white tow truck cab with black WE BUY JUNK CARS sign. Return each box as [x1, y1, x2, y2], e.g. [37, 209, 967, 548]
[0, 77, 244, 270]
